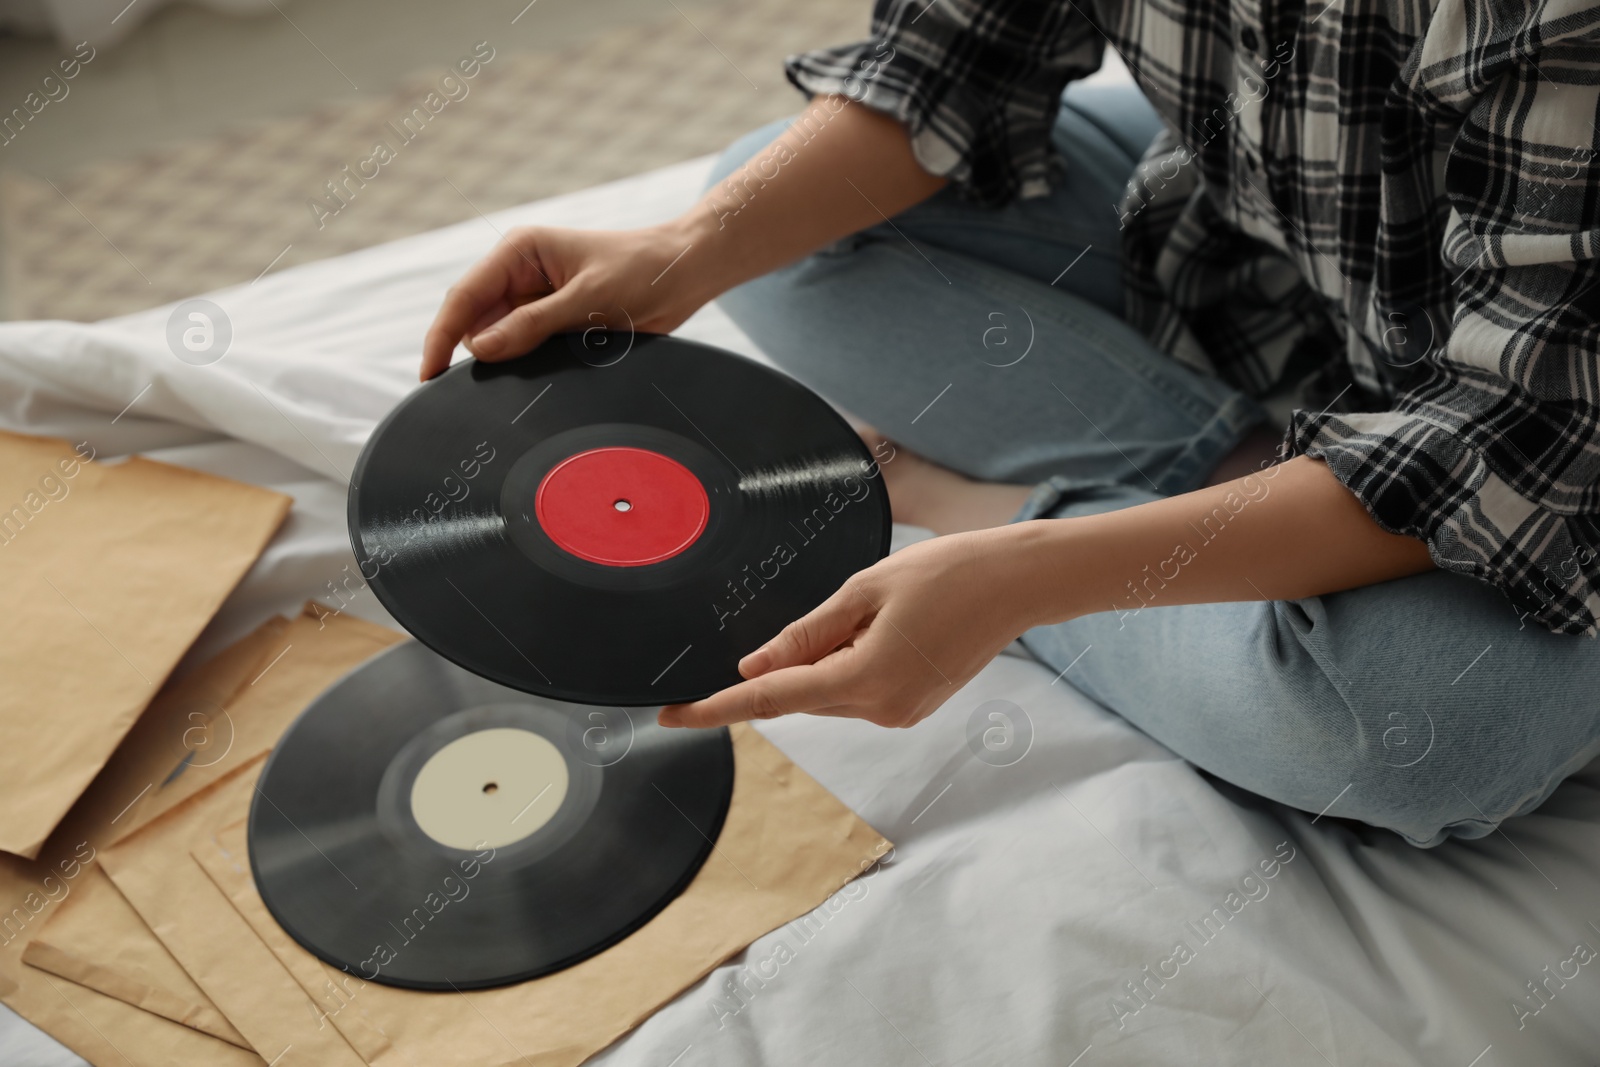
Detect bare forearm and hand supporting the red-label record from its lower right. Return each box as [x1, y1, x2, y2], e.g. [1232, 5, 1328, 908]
[661, 456, 1434, 726]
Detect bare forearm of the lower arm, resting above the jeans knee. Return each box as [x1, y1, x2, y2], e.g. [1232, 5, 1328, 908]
[992, 456, 1432, 627]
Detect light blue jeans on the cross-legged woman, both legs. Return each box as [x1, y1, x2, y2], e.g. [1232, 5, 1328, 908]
[714, 86, 1600, 846]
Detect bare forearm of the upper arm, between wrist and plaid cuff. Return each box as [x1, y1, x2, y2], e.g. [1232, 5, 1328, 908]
[669, 96, 946, 302]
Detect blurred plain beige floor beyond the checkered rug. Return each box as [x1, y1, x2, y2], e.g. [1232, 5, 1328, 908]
[0, 0, 715, 181]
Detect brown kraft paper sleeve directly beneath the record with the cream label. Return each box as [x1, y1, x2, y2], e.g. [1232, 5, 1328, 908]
[194, 725, 890, 1067]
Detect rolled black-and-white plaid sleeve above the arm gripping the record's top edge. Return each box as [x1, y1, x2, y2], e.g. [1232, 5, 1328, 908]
[786, 0, 1104, 205]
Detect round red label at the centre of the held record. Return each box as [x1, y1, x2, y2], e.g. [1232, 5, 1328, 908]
[533, 445, 710, 566]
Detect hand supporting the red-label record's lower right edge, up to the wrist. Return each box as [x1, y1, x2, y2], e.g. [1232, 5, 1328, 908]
[661, 523, 1048, 726]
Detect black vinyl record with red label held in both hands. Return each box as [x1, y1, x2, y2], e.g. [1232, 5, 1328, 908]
[349, 333, 890, 705]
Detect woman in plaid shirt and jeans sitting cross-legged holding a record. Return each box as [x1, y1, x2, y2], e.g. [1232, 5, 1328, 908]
[422, 0, 1600, 846]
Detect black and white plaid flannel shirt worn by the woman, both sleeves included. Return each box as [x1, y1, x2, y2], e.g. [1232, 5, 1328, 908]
[789, 0, 1600, 635]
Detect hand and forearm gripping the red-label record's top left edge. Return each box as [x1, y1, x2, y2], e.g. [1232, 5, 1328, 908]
[422, 96, 944, 381]
